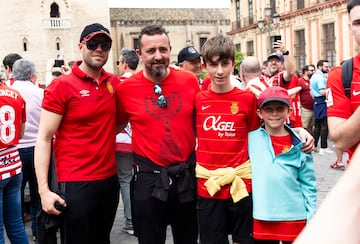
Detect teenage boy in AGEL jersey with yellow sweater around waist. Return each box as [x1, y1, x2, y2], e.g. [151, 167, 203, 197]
[195, 35, 260, 244]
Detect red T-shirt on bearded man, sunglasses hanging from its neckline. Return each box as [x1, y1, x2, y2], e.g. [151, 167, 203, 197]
[116, 68, 200, 166]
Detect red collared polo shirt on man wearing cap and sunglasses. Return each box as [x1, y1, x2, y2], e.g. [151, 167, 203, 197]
[42, 62, 120, 182]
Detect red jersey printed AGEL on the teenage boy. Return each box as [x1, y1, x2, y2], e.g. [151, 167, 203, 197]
[196, 88, 260, 199]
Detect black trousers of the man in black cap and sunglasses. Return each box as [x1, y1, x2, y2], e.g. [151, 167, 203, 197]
[59, 175, 120, 244]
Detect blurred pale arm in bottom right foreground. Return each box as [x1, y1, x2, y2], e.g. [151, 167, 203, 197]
[294, 144, 360, 244]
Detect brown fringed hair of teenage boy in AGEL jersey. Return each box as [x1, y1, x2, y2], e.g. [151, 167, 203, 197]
[201, 34, 235, 62]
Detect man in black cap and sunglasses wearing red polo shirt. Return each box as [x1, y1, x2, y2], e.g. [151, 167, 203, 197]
[35, 23, 119, 244]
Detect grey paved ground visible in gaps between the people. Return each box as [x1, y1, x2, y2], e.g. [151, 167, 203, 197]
[9, 141, 347, 244]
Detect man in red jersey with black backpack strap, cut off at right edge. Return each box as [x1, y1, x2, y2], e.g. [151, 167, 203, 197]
[326, 0, 360, 162]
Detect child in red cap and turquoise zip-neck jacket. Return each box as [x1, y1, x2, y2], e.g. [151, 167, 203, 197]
[249, 87, 316, 244]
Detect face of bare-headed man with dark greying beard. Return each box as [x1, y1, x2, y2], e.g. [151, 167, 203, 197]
[138, 31, 171, 82]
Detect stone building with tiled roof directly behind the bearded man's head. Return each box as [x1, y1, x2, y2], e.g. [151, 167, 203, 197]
[110, 8, 230, 70]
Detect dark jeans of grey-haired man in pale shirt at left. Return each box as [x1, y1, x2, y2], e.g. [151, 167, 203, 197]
[19, 147, 40, 236]
